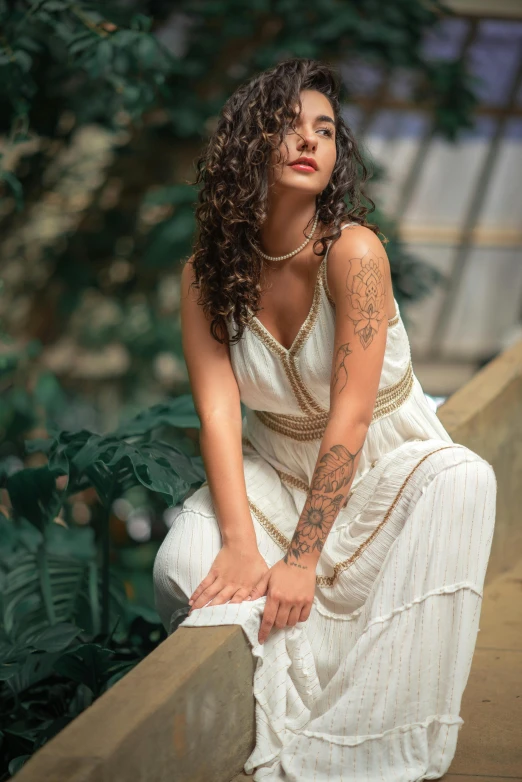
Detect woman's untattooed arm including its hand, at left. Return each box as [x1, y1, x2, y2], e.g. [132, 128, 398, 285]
[181, 260, 268, 612]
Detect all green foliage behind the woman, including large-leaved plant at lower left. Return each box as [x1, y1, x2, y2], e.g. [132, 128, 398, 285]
[0, 0, 476, 779]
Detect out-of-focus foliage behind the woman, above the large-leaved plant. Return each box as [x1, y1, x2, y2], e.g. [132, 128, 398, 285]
[0, 0, 475, 428]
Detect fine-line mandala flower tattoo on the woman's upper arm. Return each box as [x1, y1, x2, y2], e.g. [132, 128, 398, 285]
[346, 251, 386, 350]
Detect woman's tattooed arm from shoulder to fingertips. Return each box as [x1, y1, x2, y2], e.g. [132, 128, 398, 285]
[251, 226, 392, 643]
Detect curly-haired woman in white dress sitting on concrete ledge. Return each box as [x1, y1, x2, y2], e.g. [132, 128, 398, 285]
[154, 59, 496, 782]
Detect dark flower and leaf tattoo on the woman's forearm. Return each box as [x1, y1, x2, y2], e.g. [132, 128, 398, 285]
[284, 444, 362, 567]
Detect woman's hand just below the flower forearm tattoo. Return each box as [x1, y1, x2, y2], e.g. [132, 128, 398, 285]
[250, 559, 315, 644]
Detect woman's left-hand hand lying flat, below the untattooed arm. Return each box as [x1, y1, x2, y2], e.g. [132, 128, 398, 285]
[189, 545, 268, 614]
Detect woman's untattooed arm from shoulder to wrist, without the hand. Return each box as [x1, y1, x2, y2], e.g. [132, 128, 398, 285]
[181, 259, 257, 551]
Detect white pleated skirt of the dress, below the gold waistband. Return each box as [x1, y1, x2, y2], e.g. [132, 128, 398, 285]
[154, 439, 497, 782]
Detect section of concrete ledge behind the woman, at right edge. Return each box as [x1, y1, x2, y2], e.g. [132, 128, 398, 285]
[438, 342, 522, 583]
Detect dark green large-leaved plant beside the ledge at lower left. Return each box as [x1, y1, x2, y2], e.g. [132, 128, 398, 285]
[0, 397, 205, 778]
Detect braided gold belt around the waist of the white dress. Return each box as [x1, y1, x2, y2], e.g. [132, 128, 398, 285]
[254, 361, 414, 441]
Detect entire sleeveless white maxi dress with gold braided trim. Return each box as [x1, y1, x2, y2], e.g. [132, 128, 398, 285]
[154, 223, 496, 782]
